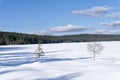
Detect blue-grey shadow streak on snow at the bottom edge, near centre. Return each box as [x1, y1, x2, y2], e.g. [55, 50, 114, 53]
[34, 73, 81, 80]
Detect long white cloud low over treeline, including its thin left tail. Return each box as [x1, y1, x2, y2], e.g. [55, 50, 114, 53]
[36, 24, 89, 35]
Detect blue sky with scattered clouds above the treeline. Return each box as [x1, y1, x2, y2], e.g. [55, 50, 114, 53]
[0, 0, 120, 35]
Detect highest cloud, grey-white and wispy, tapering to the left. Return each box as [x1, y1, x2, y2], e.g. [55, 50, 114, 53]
[72, 6, 113, 17]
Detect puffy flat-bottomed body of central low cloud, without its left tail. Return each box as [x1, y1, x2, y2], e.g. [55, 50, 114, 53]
[49, 24, 88, 32]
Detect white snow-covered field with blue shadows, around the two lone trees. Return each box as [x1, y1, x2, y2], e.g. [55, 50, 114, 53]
[0, 41, 120, 80]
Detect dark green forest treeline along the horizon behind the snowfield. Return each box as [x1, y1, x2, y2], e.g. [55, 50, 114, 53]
[0, 31, 120, 45]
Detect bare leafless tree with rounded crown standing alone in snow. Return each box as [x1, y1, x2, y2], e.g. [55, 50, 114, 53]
[87, 42, 104, 61]
